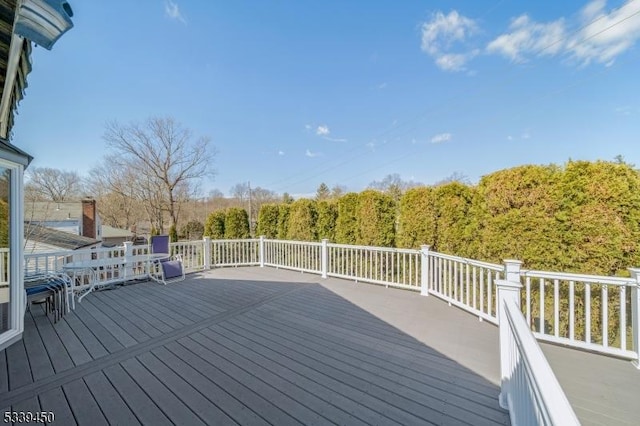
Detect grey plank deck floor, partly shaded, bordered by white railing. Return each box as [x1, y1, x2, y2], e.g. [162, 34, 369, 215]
[0, 268, 640, 426]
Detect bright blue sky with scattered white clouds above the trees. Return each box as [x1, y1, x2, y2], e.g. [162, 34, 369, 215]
[13, 0, 640, 194]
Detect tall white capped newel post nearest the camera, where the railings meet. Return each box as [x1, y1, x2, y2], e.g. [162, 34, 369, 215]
[496, 260, 522, 409]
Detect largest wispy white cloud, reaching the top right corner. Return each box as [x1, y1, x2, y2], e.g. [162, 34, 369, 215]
[487, 0, 640, 66]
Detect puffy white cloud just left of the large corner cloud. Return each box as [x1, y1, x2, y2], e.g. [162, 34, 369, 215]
[421, 10, 478, 71]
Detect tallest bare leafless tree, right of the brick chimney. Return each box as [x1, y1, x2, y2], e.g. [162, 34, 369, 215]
[104, 117, 215, 232]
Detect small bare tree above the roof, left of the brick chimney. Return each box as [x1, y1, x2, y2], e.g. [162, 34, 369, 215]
[25, 167, 82, 203]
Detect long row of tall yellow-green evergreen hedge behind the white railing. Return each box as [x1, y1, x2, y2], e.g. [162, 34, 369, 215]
[246, 161, 640, 275]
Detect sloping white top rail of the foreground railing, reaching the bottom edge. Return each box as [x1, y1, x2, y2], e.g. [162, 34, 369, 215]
[504, 299, 580, 425]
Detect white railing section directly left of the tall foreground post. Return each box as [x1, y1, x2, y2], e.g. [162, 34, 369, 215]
[423, 249, 504, 324]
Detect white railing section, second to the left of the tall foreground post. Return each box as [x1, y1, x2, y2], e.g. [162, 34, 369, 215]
[326, 244, 421, 290]
